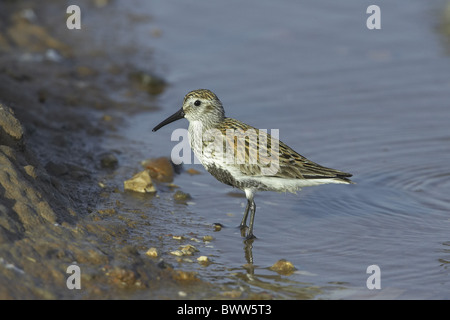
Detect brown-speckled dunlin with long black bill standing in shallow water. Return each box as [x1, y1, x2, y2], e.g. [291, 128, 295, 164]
[153, 89, 352, 239]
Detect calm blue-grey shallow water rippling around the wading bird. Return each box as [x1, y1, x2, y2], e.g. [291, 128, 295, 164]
[105, 0, 450, 299]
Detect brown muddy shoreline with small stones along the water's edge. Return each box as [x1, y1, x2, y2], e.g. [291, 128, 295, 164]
[0, 1, 225, 299]
